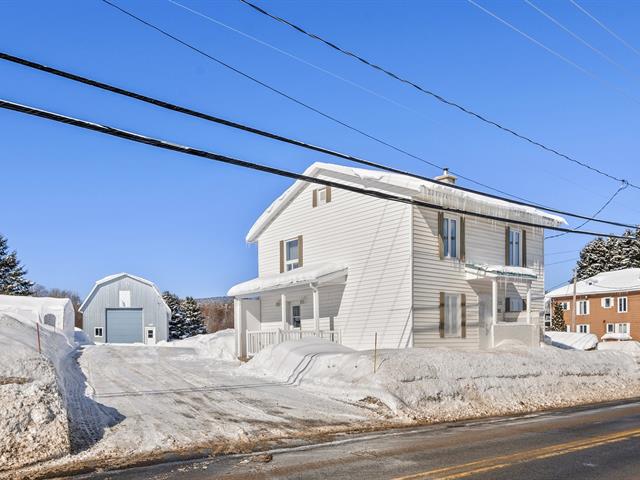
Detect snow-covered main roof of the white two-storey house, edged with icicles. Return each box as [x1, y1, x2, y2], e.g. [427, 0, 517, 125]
[246, 162, 567, 242]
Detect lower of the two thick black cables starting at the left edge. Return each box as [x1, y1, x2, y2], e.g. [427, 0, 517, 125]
[0, 100, 626, 238]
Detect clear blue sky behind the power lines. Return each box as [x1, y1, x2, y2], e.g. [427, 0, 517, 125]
[0, 0, 640, 297]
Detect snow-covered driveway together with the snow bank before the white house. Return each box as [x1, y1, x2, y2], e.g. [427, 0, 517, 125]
[7, 331, 640, 478]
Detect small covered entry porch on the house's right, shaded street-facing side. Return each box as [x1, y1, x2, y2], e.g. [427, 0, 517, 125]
[465, 264, 540, 348]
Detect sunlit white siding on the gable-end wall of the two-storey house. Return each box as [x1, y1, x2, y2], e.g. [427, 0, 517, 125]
[258, 179, 412, 349]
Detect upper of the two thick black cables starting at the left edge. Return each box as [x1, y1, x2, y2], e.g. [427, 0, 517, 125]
[0, 52, 635, 228]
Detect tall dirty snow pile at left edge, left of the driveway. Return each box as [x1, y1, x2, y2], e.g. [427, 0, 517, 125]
[0, 313, 72, 472]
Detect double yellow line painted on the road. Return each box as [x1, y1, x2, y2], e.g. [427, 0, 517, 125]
[394, 429, 640, 480]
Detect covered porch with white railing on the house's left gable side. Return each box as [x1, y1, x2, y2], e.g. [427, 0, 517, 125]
[229, 264, 348, 358]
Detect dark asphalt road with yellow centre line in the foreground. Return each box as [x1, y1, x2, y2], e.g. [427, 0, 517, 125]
[67, 401, 640, 480]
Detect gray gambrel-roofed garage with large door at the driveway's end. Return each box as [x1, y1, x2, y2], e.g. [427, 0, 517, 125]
[80, 273, 171, 345]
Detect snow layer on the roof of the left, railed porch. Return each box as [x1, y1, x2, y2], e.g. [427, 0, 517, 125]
[227, 263, 347, 297]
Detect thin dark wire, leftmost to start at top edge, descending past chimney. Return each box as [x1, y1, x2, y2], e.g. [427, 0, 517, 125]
[102, 0, 544, 202]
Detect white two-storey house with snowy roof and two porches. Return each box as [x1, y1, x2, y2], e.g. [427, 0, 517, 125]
[229, 163, 565, 357]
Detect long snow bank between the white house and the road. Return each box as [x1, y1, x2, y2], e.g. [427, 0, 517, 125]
[241, 339, 640, 421]
